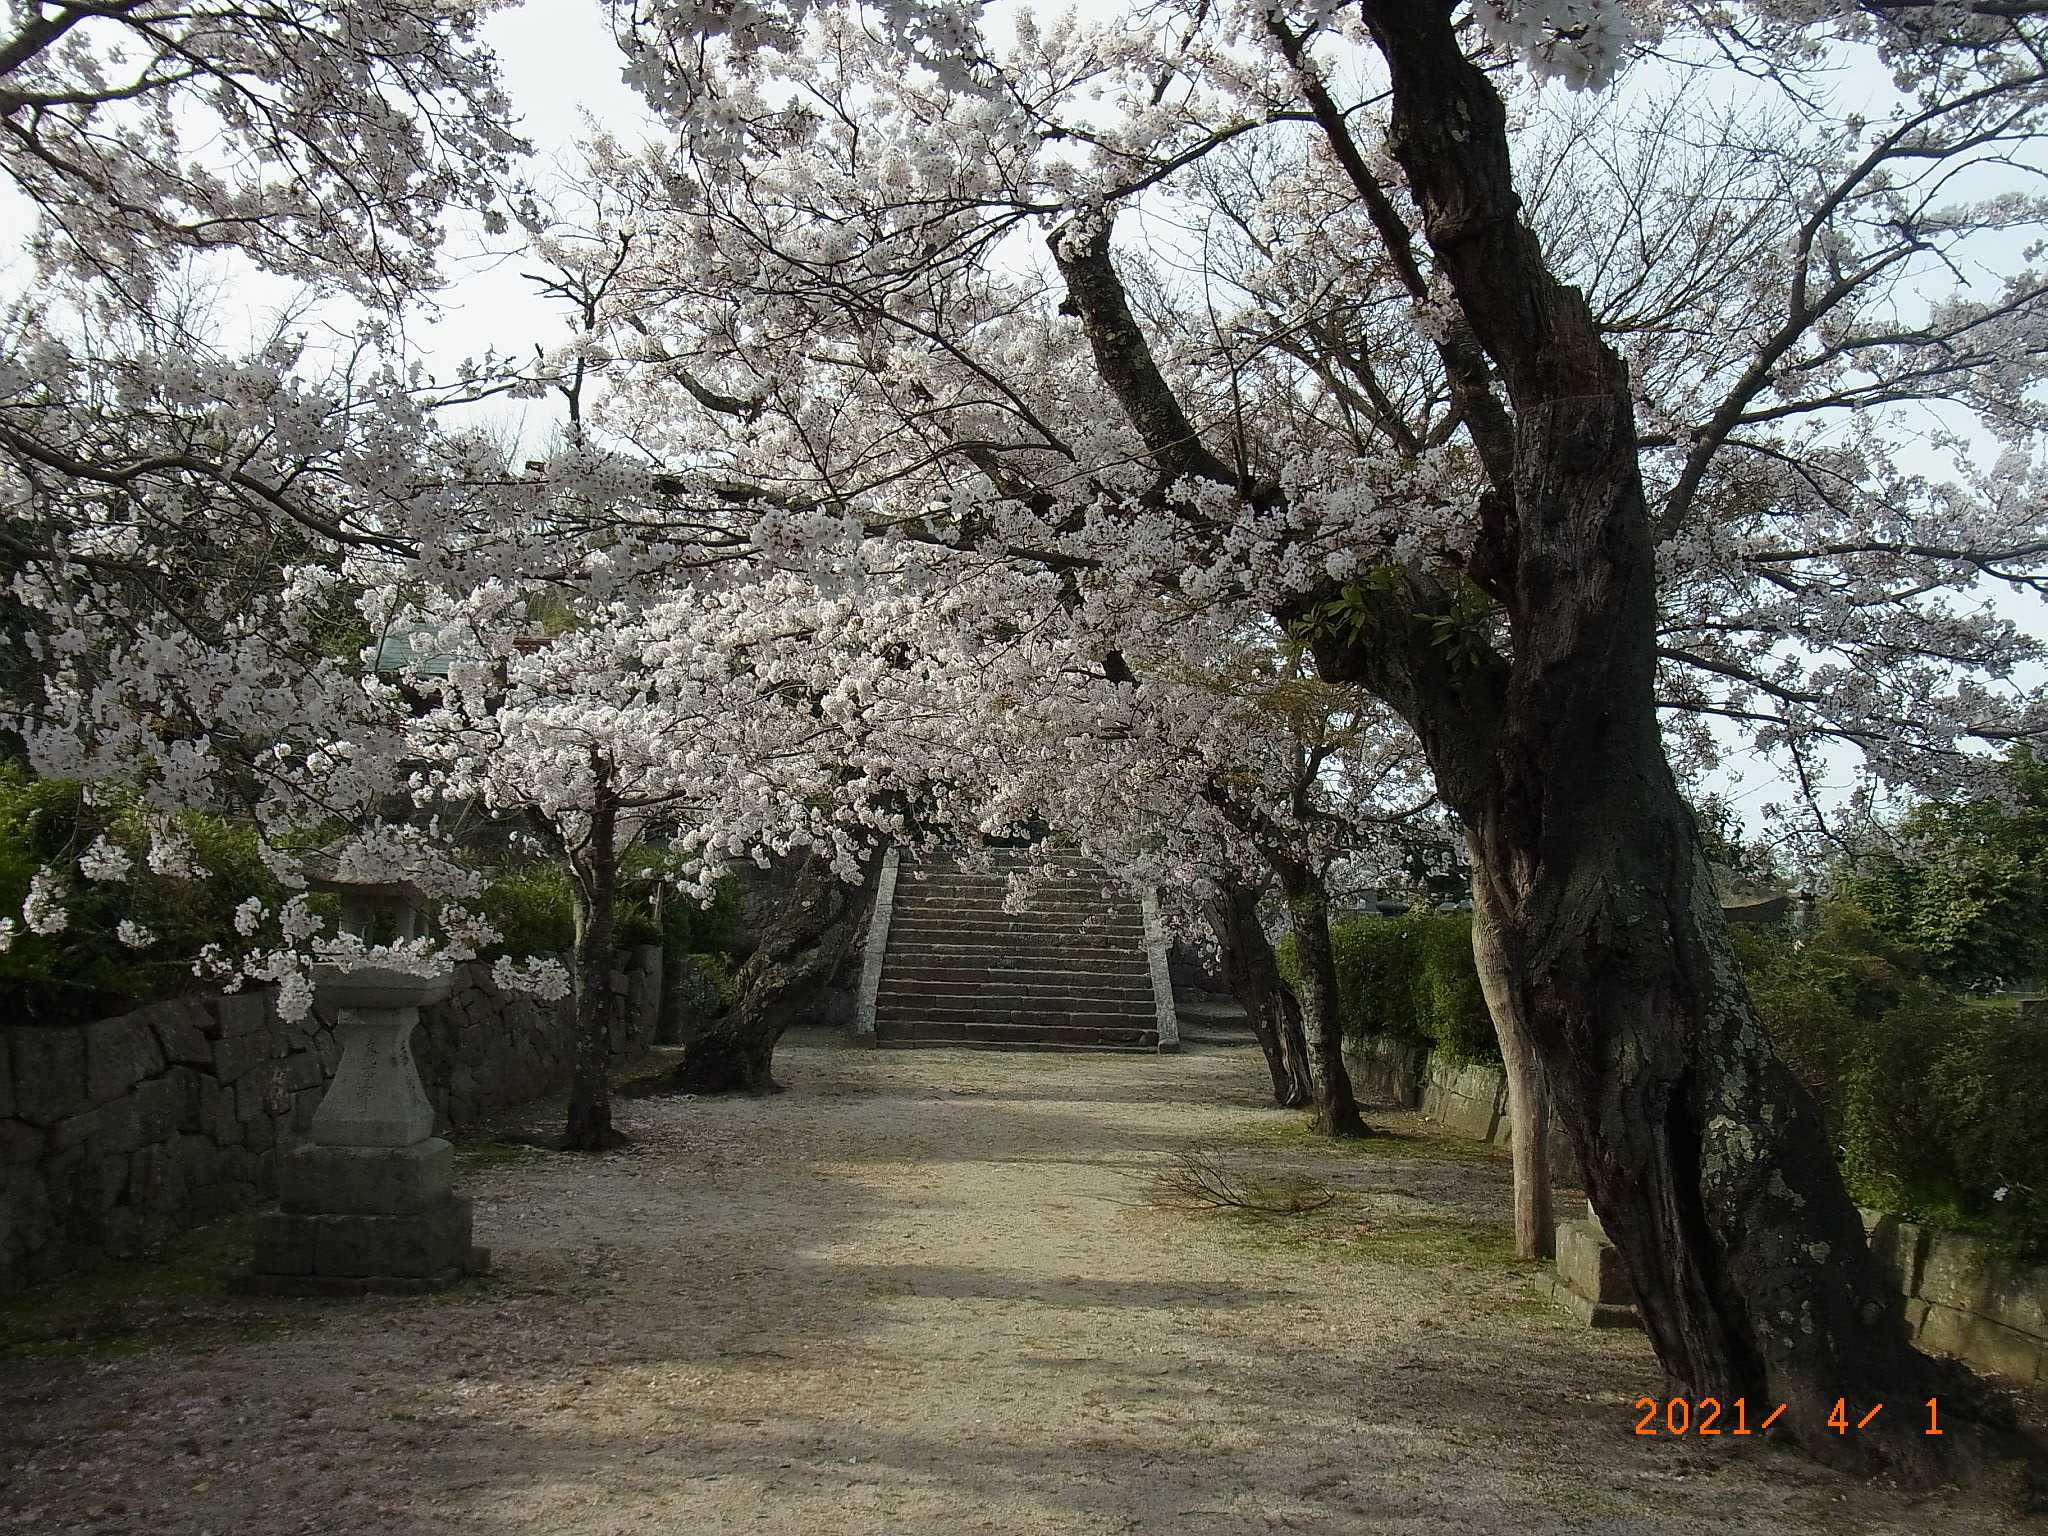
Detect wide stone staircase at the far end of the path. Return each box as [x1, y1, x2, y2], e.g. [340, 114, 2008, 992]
[874, 854, 1178, 1051]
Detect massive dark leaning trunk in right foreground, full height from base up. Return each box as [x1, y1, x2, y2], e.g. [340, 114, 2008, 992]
[1319, 0, 2023, 1479]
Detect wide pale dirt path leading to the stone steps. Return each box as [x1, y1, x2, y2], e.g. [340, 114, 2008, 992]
[0, 1036, 2039, 1536]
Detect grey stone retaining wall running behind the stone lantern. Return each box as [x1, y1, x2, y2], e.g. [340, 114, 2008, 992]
[0, 946, 662, 1292]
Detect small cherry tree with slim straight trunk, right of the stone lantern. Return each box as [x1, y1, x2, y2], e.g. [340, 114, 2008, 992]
[403, 584, 897, 1151]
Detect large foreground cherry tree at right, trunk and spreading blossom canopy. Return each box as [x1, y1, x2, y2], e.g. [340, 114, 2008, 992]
[573, 0, 2044, 1475]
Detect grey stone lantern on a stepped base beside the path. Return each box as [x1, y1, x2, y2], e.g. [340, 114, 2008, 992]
[250, 870, 485, 1294]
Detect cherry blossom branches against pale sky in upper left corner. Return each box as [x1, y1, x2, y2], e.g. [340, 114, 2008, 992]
[0, 0, 524, 313]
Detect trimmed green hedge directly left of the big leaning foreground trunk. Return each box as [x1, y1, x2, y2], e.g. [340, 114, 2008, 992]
[1280, 911, 1501, 1065]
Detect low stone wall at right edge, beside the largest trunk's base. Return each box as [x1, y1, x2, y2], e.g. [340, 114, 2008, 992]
[1864, 1210, 2048, 1386]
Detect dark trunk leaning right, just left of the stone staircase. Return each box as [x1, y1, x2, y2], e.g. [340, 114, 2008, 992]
[672, 854, 864, 1094]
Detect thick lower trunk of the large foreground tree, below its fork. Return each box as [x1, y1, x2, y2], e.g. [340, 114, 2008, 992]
[1475, 757, 1985, 1475]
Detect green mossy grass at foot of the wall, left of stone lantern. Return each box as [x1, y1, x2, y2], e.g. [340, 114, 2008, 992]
[0, 1214, 296, 1360]
